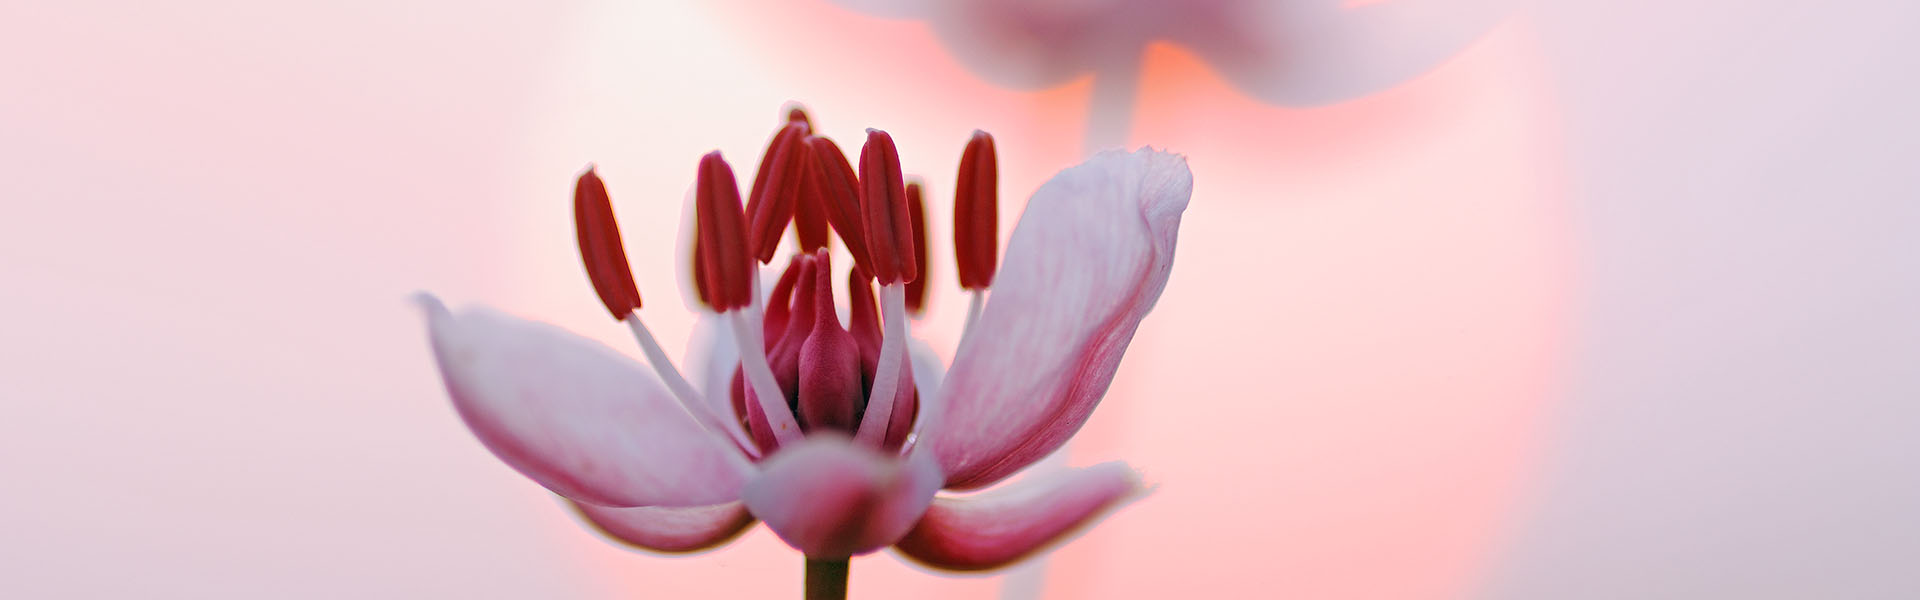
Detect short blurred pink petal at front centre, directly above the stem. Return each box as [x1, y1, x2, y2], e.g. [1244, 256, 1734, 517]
[743, 433, 941, 558]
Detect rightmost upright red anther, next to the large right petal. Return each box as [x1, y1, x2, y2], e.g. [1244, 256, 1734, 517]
[954, 131, 1000, 290]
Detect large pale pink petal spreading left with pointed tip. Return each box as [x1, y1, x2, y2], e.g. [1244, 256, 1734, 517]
[420, 296, 753, 506]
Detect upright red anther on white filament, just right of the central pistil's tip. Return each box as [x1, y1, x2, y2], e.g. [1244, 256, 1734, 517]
[860, 129, 918, 285]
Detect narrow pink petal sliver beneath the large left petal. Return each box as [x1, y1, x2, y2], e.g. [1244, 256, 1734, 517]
[570, 502, 753, 554]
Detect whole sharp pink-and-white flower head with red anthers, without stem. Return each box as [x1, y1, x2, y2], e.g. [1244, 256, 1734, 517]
[420, 110, 1192, 571]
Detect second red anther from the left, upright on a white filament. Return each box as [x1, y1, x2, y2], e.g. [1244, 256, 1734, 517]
[693, 150, 753, 312]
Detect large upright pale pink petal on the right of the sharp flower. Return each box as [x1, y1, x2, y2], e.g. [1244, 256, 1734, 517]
[929, 148, 1192, 488]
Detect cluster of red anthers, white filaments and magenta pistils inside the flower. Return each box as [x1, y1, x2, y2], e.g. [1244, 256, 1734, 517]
[574, 108, 998, 456]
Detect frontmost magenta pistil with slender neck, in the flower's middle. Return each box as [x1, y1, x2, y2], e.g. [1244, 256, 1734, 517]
[799, 250, 866, 433]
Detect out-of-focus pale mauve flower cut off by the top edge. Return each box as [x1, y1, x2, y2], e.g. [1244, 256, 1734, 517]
[835, 0, 1511, 106]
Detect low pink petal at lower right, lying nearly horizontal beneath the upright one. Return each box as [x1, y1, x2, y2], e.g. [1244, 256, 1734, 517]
[895, 463, 1140, 571]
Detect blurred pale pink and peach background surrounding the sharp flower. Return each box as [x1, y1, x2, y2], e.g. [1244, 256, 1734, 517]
[0, 0, 1920, 598]
